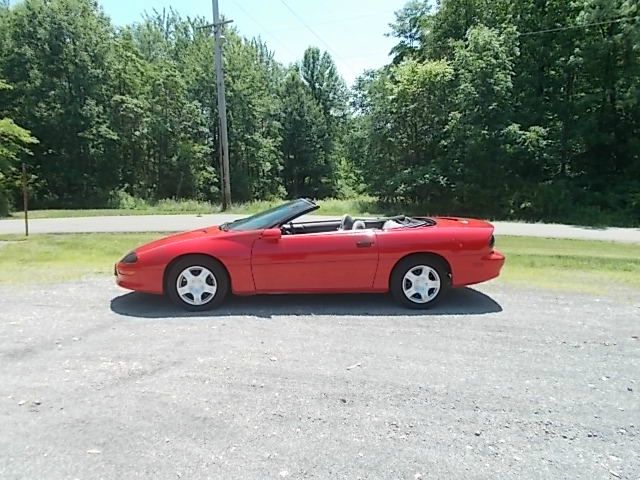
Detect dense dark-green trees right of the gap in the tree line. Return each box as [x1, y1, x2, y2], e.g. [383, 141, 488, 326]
[355, 0, 640, 224]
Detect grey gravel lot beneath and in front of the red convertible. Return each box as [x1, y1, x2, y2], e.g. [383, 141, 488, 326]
[0, 278, 640, 480]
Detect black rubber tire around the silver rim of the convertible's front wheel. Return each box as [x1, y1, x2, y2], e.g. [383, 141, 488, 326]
[165, 255, 229, 312]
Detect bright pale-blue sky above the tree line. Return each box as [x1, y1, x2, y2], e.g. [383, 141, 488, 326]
[99, 0, 406, 85]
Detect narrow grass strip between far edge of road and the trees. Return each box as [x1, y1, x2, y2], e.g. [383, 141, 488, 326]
[9, 197, 376, 220]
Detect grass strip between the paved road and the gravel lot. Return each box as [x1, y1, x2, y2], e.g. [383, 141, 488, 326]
[0, 233, 640, 294]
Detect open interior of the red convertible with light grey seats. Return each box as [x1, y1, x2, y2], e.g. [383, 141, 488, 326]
[280, 215, 435, 235]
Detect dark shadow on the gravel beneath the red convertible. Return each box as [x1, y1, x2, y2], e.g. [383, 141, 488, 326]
[111, 288, 502, 318]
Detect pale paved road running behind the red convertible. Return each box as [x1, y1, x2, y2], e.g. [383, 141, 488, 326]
[0, 215, 640, 243]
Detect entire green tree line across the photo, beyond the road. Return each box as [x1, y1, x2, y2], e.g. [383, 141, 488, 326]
[0, 0, 640, 224]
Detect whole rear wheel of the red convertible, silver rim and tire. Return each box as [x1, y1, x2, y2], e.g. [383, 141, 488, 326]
[390, 255, 451, 309]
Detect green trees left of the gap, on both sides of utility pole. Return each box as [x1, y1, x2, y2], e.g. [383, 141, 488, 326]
[0, 0, 348, 207]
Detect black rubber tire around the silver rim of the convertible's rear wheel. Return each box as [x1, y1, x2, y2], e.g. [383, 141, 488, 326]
[389, 254, 451, 309]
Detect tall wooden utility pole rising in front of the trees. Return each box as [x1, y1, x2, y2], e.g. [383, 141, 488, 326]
[211, 0, 233, 210]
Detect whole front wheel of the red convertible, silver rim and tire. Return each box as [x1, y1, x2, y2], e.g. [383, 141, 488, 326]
[166, 255, 229, 312]
